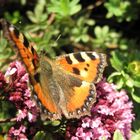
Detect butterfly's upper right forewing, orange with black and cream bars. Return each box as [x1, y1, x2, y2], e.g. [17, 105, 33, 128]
[56, 52, 107, 83]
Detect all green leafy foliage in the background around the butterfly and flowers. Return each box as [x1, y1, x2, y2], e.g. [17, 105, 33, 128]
[0, 0, 140, 140]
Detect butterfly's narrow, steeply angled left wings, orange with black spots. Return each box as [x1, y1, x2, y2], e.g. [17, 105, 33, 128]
[0, 19, 61, 119]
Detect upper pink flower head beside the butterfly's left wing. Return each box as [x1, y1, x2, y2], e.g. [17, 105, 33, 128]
[5, 61, 39, 122]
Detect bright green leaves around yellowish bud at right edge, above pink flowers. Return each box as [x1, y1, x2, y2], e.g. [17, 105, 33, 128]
[108, 50, 140, 103]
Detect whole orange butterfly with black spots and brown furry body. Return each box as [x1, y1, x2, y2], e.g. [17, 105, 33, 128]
[0, 19, 107, 120]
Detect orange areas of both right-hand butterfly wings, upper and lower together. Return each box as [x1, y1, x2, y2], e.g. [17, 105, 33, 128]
[56, 52, 107, 118]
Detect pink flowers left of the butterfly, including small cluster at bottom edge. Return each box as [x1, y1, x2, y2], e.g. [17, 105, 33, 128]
[0, 61, 39, 140]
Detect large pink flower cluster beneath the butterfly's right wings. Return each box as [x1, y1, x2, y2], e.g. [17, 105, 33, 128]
[66, 80, 134, 140]
